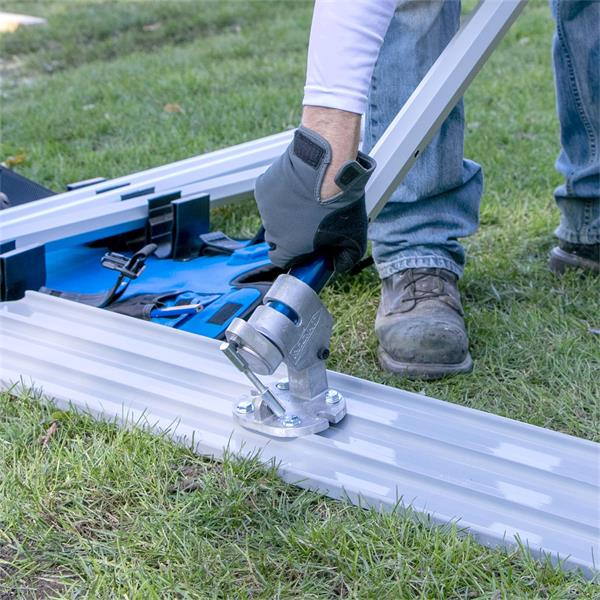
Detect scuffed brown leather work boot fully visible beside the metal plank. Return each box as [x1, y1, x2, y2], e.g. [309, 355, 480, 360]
[375, 268, 473, 379]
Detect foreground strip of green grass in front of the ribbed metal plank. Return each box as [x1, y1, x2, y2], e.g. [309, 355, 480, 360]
[0, 386, 593, 599]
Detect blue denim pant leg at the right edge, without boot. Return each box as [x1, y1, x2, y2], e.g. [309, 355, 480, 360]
[550, 0, 600, 244]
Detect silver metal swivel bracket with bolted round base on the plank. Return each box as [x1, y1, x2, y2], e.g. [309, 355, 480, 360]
[222, 275, 346, 437]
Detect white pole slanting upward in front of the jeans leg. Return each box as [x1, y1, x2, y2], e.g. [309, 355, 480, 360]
[366, 0, 527, 220]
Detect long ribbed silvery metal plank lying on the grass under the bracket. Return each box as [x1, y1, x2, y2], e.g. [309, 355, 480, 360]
[0, 292, 600, 576]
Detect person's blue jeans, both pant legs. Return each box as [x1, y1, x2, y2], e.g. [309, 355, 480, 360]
[364, 0, 600, 278]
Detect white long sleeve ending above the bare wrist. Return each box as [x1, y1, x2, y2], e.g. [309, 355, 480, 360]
[303, 0, 398, 114]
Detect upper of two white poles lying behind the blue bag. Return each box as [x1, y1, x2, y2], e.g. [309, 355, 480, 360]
[0, 131, 294, 223]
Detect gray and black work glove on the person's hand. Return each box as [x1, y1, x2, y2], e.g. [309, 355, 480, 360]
[255, 127, 375, 272]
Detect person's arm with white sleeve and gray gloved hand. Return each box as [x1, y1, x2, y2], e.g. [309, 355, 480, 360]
[255, 0, 397, 271]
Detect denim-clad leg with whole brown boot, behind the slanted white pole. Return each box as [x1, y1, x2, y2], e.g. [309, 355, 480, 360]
[365, 0, 483, 378]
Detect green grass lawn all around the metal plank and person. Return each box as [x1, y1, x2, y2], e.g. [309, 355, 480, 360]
[0, 0, 600, 600]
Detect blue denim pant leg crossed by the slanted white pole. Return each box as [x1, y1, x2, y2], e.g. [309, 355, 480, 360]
[364, 0, 483, 278]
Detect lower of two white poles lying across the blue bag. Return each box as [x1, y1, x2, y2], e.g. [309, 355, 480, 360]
[0, 164, 268, 248]
